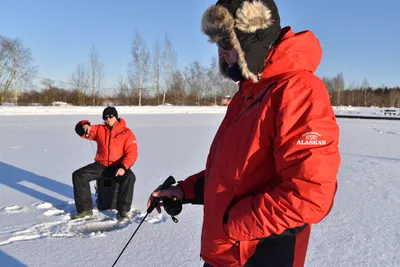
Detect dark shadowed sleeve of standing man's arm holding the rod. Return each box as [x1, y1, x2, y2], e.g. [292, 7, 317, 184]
[178, 170, 205, 204]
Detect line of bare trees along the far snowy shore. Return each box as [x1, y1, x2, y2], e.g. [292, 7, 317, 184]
[0, 31, 400, 107]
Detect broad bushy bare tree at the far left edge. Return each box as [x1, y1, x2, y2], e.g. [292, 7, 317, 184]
[0, 36, 37, 104]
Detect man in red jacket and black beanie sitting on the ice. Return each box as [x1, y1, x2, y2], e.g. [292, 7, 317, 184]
[72, 107, 138, 220]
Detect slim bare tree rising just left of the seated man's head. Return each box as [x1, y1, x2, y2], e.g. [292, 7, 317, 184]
[90, 45, 104, 106]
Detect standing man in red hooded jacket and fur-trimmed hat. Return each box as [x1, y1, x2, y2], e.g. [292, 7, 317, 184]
[149, 0, 340, 267]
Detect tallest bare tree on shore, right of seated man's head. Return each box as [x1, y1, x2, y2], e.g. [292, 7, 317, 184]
[128, 31, 149, 106]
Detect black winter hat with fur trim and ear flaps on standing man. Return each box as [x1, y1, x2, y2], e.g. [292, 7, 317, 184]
[201, 0, 281, 82]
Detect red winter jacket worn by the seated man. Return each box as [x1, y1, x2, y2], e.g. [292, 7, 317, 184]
[77, 118, 138, 170]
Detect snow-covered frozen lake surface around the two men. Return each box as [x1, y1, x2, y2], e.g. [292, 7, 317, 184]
[0, 106, 400, 267]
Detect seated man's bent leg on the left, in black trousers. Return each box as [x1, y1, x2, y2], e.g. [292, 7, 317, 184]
[72, 162, 104, 214]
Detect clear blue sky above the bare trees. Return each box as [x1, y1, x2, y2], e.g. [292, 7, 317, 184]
[0, 0, 400, 91]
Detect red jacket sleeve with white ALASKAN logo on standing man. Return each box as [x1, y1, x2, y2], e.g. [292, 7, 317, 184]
[224, 76, 340, 241]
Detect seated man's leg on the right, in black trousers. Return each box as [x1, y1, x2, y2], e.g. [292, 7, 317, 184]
[116, 169, 136, 215]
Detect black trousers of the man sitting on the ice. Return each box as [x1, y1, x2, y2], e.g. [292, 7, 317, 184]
[72, 162, 136, 213]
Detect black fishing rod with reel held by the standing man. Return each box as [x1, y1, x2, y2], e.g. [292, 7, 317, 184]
[112, 176, 182, 267]
